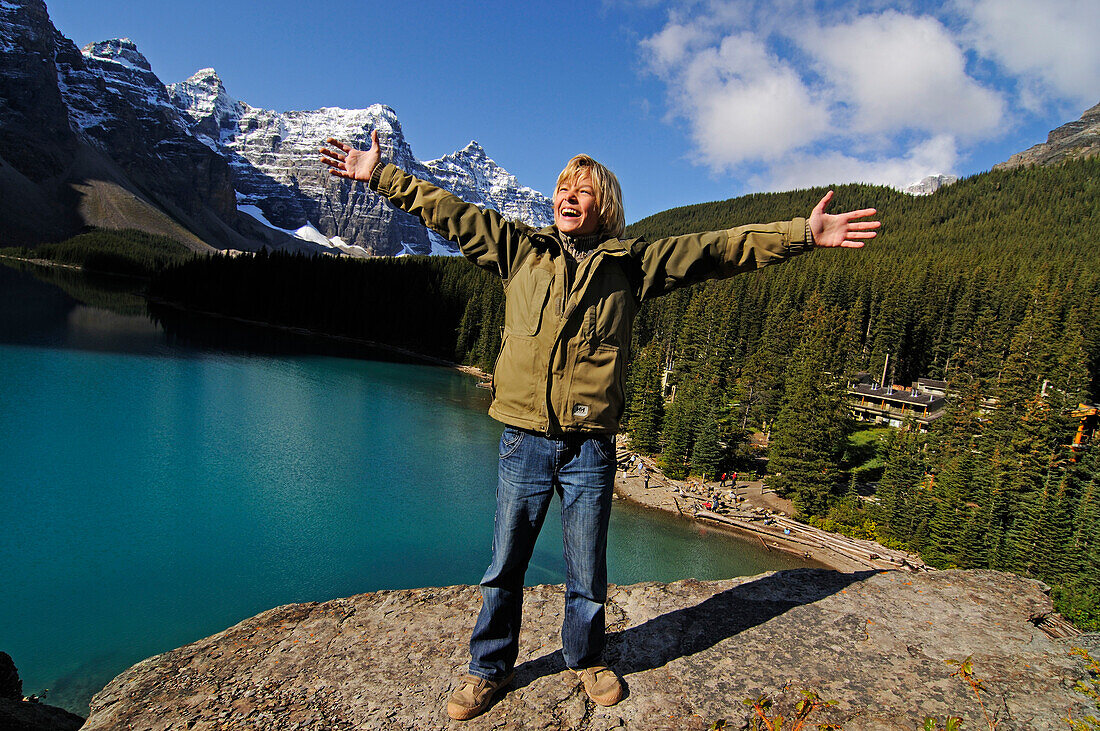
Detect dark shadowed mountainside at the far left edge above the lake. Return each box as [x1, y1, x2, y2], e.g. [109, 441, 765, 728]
[0, 0, 283, 251]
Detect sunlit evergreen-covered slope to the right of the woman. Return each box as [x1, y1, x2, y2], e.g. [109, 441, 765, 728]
[628, 159, 1100, 629]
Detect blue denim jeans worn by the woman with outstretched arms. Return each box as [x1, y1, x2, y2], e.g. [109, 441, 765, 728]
[470, 427, 615, 680]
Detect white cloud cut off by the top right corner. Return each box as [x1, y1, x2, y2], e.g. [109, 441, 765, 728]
[957, 0, 1100, 109]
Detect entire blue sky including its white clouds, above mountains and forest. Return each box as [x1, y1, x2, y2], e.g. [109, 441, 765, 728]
[46, 0, 1100, 221]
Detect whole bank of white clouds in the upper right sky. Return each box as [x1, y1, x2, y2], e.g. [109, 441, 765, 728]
[642, 0, 1100, 189]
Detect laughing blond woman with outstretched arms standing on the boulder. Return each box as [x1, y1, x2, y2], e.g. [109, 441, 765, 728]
[320, 131, 879, 720]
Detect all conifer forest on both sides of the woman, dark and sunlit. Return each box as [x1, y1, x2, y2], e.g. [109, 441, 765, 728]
[151, 158, 1100, 630]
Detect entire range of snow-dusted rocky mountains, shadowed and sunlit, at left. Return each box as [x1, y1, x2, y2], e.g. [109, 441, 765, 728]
[0, 0, 550, 256]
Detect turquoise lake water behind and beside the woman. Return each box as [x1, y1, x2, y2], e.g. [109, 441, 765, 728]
[0, 266, 806, 715]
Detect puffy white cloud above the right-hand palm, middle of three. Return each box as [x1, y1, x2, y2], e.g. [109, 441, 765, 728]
[802, 11, 1004, 136]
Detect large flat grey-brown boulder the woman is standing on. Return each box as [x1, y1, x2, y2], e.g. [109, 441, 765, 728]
[84, 569, 1098, 731]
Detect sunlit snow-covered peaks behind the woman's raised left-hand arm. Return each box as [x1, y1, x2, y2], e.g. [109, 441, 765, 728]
[168, 68, 552, 254]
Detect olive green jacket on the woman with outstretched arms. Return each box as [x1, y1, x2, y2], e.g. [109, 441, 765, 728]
[370, 165, 809, 434]
